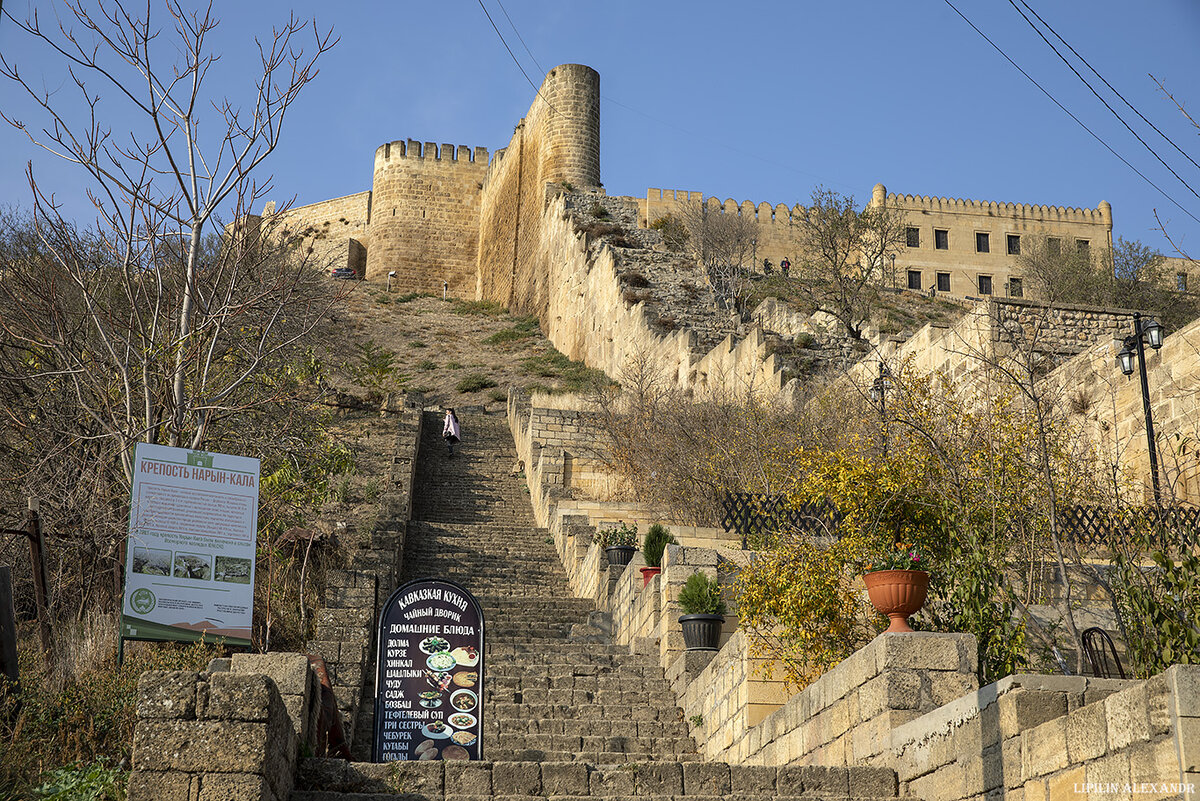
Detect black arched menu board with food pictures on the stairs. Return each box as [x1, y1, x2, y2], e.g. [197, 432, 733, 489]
[372, 579, 484, 763]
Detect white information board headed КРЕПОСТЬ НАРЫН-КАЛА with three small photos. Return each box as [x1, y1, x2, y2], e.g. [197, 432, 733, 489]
[121, 442, 259, 645]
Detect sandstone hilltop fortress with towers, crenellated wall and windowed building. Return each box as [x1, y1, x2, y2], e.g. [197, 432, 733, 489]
[250, 64, 1113, 303]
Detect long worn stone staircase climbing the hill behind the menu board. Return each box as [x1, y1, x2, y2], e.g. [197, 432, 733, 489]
[290, 412, 895, 801]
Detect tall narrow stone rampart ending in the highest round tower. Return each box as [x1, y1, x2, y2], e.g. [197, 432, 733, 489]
[476, 64, 600, 318]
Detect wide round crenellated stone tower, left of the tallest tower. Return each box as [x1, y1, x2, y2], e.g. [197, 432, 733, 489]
[366, 139, 487, 292]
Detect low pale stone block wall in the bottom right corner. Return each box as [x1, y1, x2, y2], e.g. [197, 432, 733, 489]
[888, 666, 1200, 801]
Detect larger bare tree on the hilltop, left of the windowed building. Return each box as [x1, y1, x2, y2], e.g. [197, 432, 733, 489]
[796, 186, 905, 339]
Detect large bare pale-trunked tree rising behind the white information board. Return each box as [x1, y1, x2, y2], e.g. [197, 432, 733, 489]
[0, 0, 336, 475]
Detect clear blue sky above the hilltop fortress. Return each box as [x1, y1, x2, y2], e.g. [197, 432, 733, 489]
[0, 0, 1200, 257]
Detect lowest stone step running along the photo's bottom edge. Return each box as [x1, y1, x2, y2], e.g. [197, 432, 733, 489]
[292, 753, 902, 801]
